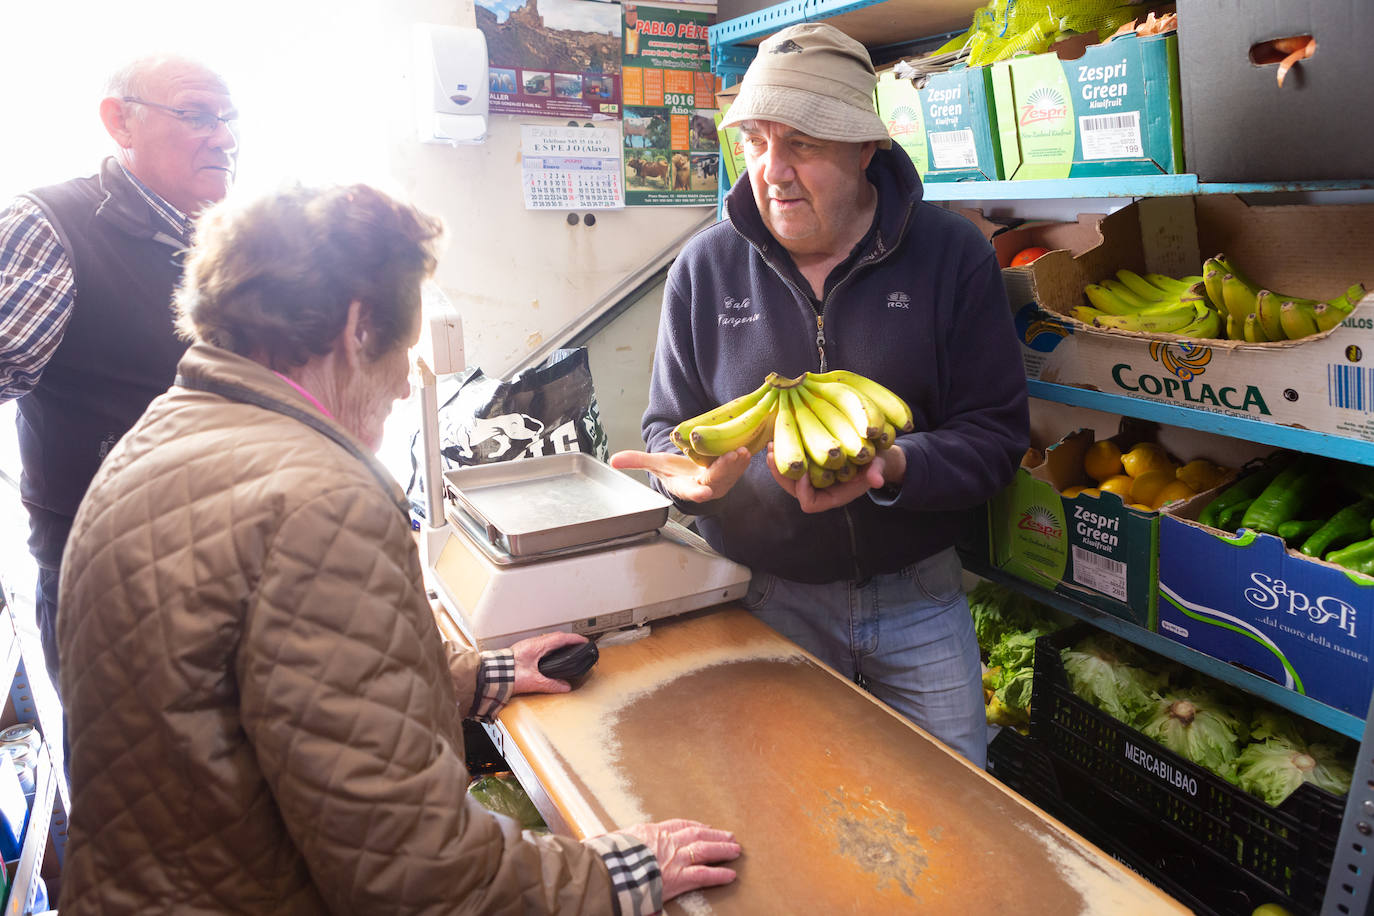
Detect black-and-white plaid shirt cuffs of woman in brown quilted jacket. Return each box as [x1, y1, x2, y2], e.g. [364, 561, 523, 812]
[471, 648, 664, 916]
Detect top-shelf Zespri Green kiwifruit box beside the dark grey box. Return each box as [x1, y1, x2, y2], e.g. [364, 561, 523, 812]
[989, 33, 1183, 180]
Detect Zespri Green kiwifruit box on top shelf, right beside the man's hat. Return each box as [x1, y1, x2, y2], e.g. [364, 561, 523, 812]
[877, 67, 1002, 183]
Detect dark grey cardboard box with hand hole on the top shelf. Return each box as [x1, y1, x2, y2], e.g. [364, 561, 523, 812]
[1179, 0, 1374, 181]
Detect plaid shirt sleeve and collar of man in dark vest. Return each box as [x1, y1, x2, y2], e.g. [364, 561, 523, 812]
[0, 169, 191, 401]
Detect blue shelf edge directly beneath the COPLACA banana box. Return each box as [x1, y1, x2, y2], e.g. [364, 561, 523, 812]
[1026, 379, 1374, 464]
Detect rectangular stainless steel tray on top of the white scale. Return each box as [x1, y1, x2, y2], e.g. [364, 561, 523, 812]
[444, 452, 671, 556]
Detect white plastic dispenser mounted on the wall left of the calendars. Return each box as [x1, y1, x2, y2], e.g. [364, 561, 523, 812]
[415, 25, 488, 146]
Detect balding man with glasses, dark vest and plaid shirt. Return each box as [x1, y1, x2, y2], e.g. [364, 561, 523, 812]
[0, 56, 238, 684]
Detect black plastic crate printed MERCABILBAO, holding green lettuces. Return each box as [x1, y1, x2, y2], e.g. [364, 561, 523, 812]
[1031, 625, 1345, 913]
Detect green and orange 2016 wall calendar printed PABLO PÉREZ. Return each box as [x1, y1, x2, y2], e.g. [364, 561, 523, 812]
[621, 3, 720, 206]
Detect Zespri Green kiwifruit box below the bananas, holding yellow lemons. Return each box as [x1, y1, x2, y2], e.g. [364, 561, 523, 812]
[988, 428, 1160, 630]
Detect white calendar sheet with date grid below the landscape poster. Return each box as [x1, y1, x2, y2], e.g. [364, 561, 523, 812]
[521, 124, 625, 210]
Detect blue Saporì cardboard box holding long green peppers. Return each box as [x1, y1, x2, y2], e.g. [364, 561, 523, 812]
[1157, 500, 1374, 718]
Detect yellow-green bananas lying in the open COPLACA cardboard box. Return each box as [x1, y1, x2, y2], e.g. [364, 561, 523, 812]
[1073, 254, 1364, 343]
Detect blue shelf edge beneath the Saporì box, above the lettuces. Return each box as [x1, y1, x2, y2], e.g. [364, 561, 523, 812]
[963, 555, 1364, 740]
